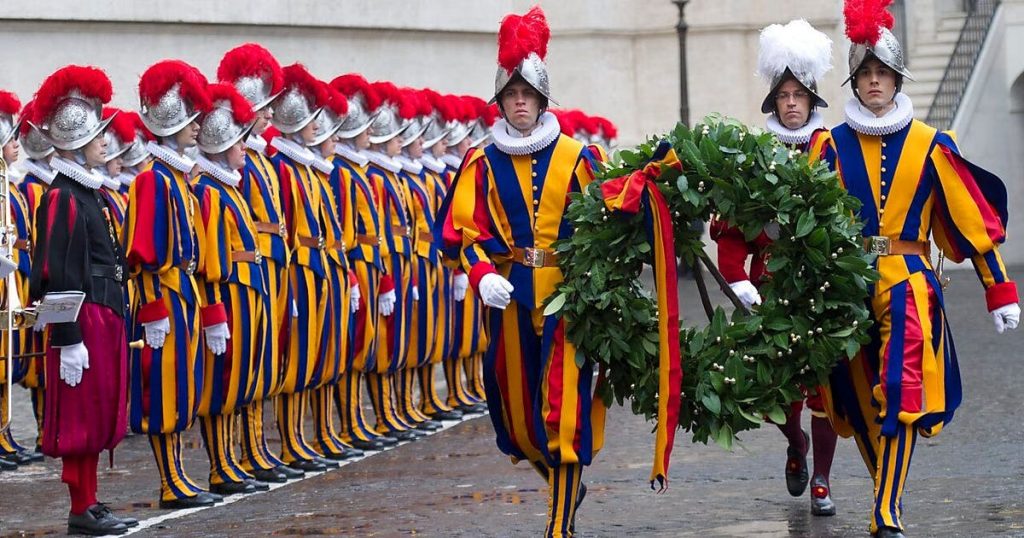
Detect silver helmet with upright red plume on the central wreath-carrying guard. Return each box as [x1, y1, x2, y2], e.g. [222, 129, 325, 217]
[487, 6, 558, 105]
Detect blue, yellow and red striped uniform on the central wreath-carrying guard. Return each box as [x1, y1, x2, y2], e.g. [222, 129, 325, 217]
[435, 135, 604, 535]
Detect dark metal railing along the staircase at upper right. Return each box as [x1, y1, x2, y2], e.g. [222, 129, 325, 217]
[925, 0, 999, 129]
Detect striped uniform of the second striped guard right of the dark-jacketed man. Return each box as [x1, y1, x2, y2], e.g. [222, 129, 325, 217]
[194, 173, 267, 484]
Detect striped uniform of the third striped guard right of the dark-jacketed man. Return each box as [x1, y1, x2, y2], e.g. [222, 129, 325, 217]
[239, 136, 291, 471]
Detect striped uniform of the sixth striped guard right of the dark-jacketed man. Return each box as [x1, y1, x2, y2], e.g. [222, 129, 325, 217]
[333, 153, 385, 442]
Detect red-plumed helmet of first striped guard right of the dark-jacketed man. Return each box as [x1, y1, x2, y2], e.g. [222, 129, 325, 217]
[138, 59, 210, 136]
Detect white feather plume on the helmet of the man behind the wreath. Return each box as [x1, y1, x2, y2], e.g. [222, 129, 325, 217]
[758, 18, 833, 84]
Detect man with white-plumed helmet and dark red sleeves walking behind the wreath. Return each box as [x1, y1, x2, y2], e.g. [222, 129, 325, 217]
[711, 19, 837, 515]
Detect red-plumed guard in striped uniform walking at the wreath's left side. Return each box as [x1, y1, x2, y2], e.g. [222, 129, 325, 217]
[436, 7, 604, 537]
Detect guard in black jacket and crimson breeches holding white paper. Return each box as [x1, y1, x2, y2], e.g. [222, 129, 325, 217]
[30, 66, 138, 535]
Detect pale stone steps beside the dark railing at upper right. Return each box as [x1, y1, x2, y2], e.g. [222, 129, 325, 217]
[903, 12, 967, 120]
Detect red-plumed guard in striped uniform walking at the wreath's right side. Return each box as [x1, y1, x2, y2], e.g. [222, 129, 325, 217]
[823, 0, 1020, 537]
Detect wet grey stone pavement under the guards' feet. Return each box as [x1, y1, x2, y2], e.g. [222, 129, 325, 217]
[0, 270, 1024, 537]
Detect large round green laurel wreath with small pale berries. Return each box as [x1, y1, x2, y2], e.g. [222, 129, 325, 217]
[546, 116, 879, 448]
